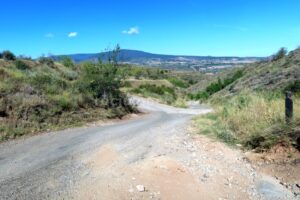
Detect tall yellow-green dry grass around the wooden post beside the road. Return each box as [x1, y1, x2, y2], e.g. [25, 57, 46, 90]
[195, 92, 300, 149]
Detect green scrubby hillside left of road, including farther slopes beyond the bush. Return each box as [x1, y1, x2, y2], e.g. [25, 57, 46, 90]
[0, 52, 205, 141]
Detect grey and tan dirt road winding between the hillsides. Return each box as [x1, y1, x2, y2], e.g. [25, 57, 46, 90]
[0, 98, 294, 200]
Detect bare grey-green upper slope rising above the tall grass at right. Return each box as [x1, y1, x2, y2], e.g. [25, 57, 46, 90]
[189, 49, 300, 96]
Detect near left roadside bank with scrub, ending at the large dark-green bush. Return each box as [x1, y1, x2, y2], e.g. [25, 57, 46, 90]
[0, 57, 135, 140]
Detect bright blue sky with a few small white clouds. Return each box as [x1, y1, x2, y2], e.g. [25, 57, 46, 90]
[0, 0, 300, 57]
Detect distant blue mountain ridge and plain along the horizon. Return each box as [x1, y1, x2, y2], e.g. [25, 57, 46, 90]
[52, 49, 264, 71]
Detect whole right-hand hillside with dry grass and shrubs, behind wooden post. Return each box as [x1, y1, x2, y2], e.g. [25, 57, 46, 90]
[189, 49, 300, 150]
